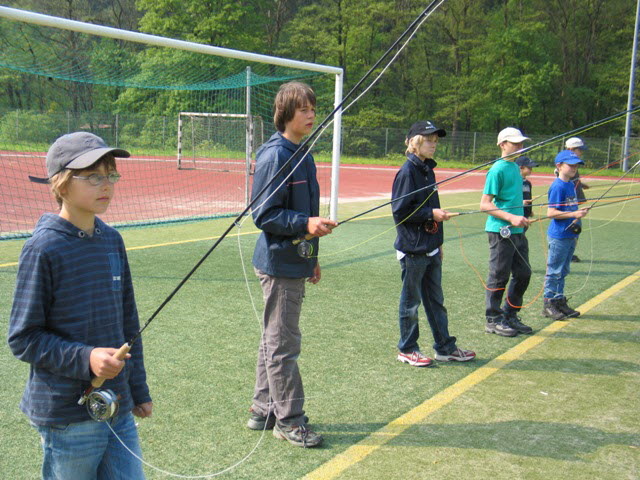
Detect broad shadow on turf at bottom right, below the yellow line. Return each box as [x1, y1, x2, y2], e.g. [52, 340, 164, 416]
[364, 420, 640, 461]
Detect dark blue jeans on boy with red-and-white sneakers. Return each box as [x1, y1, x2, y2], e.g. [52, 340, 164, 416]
[398, 253, 456, 355]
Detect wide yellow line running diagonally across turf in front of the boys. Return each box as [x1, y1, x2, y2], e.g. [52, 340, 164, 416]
[304, 270, 640, 480]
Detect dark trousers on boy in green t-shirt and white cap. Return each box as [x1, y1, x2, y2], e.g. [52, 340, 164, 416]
[486, 232, 531, 322]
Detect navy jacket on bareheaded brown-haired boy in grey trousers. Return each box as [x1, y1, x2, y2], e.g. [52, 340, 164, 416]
[251, 132, 320, 278]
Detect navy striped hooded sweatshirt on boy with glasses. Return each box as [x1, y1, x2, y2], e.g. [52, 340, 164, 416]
[8, 214, 151, 425]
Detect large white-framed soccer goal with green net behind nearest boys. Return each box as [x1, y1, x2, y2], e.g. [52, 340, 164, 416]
[0, 7, 339, 240]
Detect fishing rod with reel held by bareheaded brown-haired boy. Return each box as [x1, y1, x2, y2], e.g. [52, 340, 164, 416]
[292, 106, 640, 253]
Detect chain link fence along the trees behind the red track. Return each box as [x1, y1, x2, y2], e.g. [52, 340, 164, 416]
[0, 110, 640, 169]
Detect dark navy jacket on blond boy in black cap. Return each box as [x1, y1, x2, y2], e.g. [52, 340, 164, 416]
[391, 154, 444, 254]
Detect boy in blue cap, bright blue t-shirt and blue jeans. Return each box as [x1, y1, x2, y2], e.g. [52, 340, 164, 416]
[542, 150, 588, 320]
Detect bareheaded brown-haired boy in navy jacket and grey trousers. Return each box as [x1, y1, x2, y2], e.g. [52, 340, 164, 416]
[247, 82, 337, 447]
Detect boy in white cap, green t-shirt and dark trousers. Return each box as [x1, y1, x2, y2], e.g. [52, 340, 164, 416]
[480, 127, 533, 337]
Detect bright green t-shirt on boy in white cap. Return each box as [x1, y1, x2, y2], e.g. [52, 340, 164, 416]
[482, 159, 524, 233]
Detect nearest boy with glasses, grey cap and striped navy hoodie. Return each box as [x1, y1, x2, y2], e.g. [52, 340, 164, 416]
[8, 132, 153, 480]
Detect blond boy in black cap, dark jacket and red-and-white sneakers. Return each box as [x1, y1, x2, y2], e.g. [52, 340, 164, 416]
[391, 122, 476, 367]
